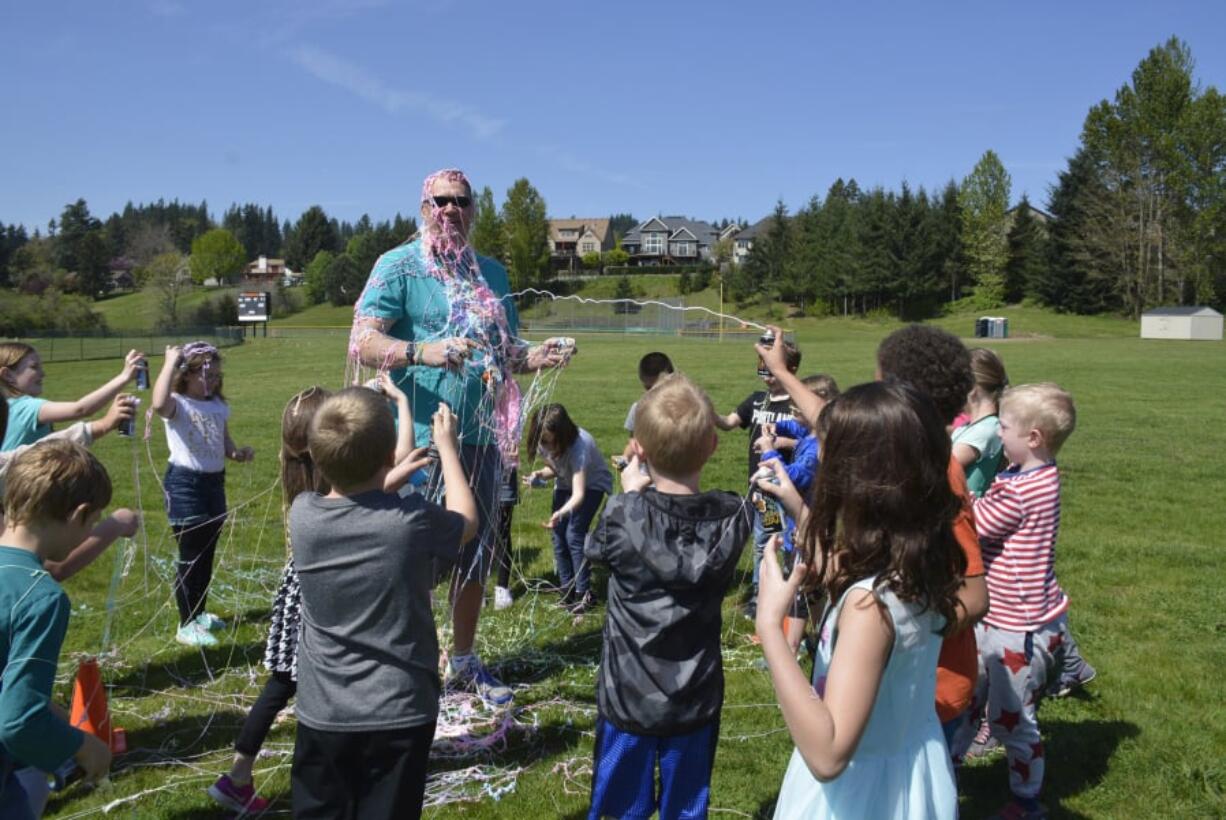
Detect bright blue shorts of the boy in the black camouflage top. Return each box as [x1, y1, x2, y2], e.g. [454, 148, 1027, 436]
[587, 717, 720, 820]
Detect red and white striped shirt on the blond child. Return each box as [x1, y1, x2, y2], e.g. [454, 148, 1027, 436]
[975, 462, 1069, 632]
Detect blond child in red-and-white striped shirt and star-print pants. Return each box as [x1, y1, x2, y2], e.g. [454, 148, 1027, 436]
[955, 384, 1076, 820]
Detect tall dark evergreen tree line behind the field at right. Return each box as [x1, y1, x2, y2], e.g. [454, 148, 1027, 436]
[726, 38, 1226, 319]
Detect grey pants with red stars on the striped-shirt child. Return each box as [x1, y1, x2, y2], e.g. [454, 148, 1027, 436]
[955, 615, 1068, 798]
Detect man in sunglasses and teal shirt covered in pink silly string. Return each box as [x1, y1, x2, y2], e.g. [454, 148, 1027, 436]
[349, 169, 574, 706]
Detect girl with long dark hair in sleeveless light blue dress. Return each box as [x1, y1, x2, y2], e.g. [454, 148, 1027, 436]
[758, 382, 966, 820]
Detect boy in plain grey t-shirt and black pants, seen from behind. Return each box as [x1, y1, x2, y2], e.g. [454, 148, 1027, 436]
[289, 387, 477, 820]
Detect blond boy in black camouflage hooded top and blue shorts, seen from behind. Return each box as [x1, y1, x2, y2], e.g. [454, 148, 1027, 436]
[585, 374, 752, 818]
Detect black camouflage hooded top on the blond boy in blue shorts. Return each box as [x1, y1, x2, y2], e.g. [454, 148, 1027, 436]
[584, 488, 753, 735]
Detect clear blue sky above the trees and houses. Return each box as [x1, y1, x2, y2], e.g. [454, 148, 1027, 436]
[0, 0, 1226, 227]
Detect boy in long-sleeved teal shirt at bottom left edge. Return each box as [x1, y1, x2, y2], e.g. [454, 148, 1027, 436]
[0, 441, 110, 818]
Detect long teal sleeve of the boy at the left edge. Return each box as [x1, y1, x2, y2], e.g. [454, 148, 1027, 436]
[0, 585, 85, 772]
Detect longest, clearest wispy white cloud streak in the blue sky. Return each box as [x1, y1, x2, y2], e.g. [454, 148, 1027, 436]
[289, 45, 505, 140]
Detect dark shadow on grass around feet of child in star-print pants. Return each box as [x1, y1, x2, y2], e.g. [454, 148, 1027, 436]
[959, 719, 1141, 819]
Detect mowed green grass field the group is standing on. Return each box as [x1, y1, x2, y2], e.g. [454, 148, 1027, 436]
[33, 309, 1226, 818]
